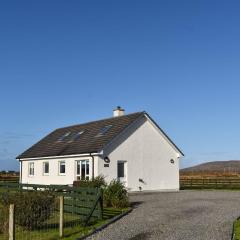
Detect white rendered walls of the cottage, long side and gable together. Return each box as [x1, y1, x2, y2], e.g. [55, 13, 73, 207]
[21, 116, 182, 191]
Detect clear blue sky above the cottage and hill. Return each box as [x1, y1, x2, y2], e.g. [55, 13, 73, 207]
[0, 0, 240, 170]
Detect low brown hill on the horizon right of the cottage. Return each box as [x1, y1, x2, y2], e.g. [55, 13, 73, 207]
[180, 160, 240, 176]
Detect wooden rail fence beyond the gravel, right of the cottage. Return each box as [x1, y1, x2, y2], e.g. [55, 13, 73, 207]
[180, 178, 240, 189]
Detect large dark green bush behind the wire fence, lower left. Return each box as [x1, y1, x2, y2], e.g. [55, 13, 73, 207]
[1, 191, 55, 230]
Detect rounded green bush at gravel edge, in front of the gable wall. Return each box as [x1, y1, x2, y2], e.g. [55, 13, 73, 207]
[103, 180, 129, 208]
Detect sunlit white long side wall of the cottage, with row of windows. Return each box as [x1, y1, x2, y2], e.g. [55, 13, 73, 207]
[19, 156, 97, 185]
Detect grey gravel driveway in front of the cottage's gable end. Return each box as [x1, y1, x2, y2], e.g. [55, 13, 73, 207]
[87, 191, 240, 240]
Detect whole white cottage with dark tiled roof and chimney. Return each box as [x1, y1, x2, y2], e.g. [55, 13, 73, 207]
[17, 107, 184, 191]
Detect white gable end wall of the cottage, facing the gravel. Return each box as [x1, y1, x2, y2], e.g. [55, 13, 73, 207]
[98, 118, 179, 191]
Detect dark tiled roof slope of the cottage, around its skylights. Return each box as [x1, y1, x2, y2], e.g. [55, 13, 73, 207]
[17, 112, 145, 159]
